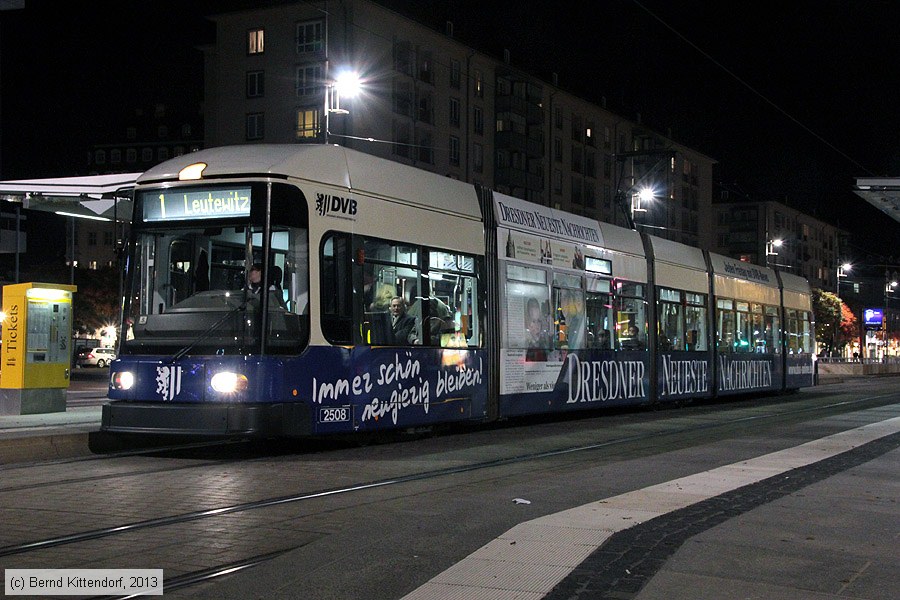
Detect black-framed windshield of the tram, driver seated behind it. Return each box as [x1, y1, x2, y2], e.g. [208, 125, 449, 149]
[122, 184, 309, 357]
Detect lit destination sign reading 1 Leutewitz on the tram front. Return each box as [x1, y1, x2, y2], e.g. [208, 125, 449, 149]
[142, 187, 250, 223]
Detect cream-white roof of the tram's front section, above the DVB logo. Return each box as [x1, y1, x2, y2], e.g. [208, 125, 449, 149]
[138, 144, 481, 220]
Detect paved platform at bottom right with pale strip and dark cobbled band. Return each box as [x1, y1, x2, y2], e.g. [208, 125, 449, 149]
[404, 417, 900, 600]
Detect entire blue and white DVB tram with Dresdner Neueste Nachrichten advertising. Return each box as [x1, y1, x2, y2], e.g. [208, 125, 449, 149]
[102, 145, 814, 437]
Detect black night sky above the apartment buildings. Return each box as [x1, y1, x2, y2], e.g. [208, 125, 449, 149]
[0, 0, 900, 255]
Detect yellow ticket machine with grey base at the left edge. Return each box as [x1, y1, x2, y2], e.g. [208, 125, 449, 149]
[0, 283, 77, 415]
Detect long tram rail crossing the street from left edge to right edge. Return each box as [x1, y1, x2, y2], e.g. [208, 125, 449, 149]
[0, 386, 897, 558]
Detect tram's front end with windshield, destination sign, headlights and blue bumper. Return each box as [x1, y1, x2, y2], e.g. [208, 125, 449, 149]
[102, 173, 309, 435]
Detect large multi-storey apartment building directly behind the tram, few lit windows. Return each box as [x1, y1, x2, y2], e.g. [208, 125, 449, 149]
[203, 0, 714, 246]
